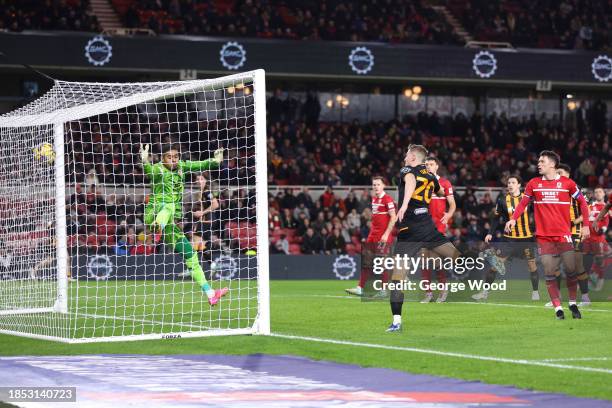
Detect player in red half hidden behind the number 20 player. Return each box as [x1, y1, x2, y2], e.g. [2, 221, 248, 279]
[421, 156, 457, 303]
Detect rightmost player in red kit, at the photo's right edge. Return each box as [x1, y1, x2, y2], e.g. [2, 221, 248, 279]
[584, 187, 612, 291]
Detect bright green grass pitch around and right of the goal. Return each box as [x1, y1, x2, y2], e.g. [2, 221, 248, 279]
[0, 281, 612, 400]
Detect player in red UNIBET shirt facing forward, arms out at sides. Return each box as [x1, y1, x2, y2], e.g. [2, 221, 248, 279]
[506, 150, 590, 319]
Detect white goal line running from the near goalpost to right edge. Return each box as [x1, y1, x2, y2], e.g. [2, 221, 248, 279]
[271, 333, 612, 374]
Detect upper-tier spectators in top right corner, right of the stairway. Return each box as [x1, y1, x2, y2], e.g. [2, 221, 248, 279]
[451, 0, 612, 50]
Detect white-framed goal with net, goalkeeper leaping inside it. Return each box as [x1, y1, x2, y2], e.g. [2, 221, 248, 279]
[0, 70, 270, 342]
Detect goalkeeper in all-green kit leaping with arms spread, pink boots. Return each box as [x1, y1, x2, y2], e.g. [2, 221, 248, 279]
[140, 145, 228, 306]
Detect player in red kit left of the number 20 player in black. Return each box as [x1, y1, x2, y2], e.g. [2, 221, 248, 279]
[346, 176, 397, 296]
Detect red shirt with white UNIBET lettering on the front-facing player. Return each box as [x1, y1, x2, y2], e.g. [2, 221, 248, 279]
[525, 176, 580, 237]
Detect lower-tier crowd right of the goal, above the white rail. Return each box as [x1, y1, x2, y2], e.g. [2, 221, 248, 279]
[268, 91, 612, 188]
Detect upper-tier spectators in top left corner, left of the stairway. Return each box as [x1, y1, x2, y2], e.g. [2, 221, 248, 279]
[0, 0, 100, 32]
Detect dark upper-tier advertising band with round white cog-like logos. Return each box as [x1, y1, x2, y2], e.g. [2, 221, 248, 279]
[0, 32, 612, 87]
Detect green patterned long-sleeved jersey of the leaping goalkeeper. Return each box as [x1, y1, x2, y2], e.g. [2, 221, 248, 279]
[143, 160, 219, 213]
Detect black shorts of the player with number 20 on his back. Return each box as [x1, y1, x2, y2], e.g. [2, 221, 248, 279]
[395, 216, 450, 256]
